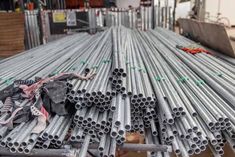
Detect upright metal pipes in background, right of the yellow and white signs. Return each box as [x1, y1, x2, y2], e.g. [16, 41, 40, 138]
[98, 6, 173, 30]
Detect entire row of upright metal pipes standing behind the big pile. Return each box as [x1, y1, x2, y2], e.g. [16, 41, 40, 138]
[28, 6, 173, 49]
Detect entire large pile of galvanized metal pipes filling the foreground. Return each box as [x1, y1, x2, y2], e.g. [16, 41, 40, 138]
[0, 27, 235, 157]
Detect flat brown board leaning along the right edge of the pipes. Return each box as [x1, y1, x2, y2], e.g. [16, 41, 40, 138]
[178, 19, 235, 58]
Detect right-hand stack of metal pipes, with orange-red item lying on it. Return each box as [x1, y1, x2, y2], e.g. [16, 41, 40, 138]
[134, 28, 235, 156]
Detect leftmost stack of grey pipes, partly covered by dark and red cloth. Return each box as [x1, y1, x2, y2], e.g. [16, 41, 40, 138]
[0, 31, 113, 154]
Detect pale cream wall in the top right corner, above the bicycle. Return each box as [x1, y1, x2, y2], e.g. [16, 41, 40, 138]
[206, 0, 235, 25]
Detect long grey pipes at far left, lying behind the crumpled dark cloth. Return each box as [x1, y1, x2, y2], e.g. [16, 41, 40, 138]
[0, 33, 99, 90]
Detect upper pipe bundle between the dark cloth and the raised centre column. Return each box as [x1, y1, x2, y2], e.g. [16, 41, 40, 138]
[68, 31, 112, 111]
